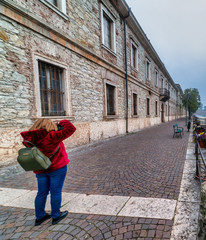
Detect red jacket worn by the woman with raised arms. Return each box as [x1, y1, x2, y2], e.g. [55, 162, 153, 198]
[21, 120, 76, 174]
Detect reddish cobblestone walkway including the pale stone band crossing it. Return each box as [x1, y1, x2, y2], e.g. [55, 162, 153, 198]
[0, 120, 198, 240]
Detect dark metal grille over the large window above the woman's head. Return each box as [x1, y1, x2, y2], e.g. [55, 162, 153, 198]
[38, 61, 65, 116]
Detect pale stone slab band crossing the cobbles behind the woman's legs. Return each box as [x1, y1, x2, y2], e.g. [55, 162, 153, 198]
[0, 188, 177, 220]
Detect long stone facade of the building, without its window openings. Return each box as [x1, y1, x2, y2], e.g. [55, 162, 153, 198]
[0, 0, 183, 164]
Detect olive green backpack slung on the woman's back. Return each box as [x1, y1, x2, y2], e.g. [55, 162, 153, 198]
[17, 141, 60, 171]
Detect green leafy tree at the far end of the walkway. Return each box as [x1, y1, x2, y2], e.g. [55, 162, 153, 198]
[182, 88, 201, 117]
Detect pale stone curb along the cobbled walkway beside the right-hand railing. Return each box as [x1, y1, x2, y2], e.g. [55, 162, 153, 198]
[170, 131, 200, 240]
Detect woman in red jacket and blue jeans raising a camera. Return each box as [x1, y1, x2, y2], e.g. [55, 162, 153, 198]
[21, 119, 76, 226]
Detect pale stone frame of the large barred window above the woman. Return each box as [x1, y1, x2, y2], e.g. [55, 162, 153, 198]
[32, 54, 73, 119]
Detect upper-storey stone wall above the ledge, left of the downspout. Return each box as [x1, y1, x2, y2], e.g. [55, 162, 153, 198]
[10, 0, 124, 68]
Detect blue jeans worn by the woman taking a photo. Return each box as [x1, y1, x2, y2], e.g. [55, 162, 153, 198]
[35, 166, 67, 219]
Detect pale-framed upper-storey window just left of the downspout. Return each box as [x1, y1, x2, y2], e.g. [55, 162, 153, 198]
[101, 5, 116, 52]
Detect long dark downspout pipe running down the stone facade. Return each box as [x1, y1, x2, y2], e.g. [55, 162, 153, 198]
[123, 8, 131, 133]
